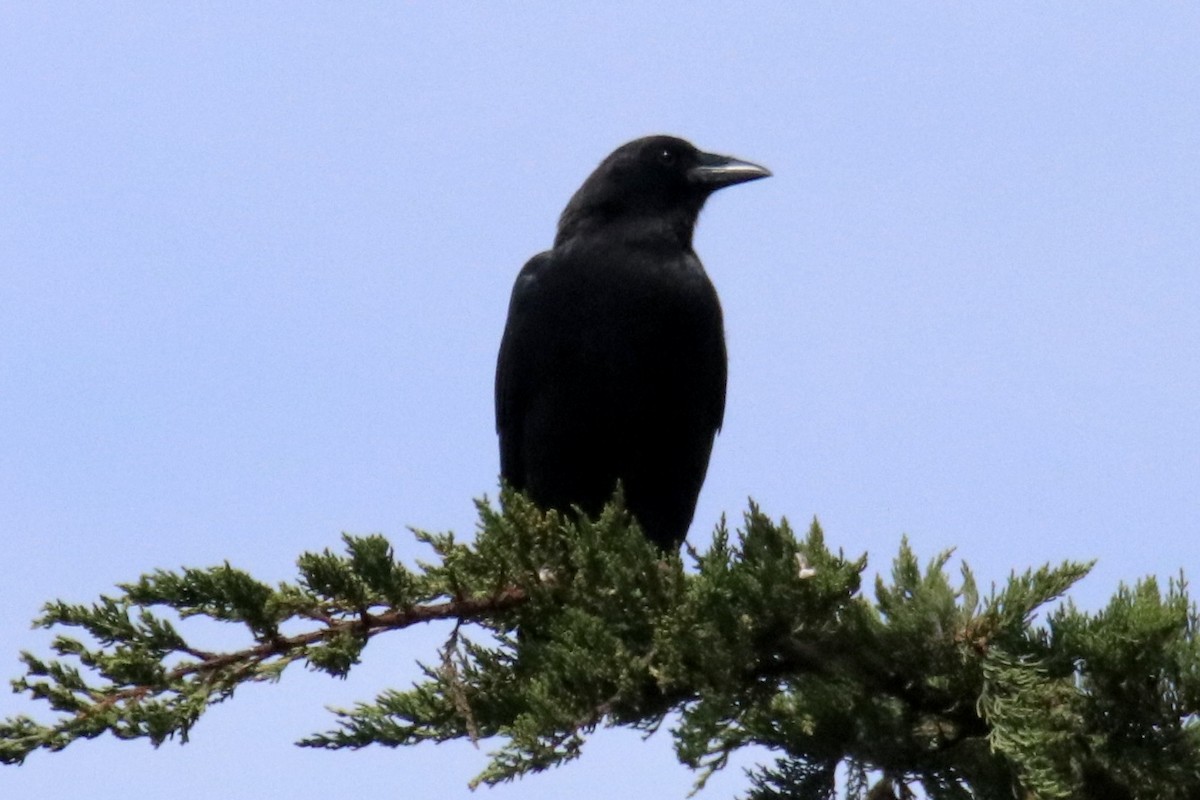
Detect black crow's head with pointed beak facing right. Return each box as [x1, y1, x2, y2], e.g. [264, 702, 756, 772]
[554, 136, 770, 246]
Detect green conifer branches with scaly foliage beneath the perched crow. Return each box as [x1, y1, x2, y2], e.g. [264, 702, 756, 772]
[0, 494, 1200, 800]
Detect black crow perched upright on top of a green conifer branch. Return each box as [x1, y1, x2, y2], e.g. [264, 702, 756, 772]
[496, 136, 770, 549]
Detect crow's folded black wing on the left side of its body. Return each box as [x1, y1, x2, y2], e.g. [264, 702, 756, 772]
[496, 251, 552, 489]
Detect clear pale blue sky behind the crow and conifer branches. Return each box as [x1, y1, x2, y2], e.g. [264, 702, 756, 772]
[0, 2, 1200, 800]
